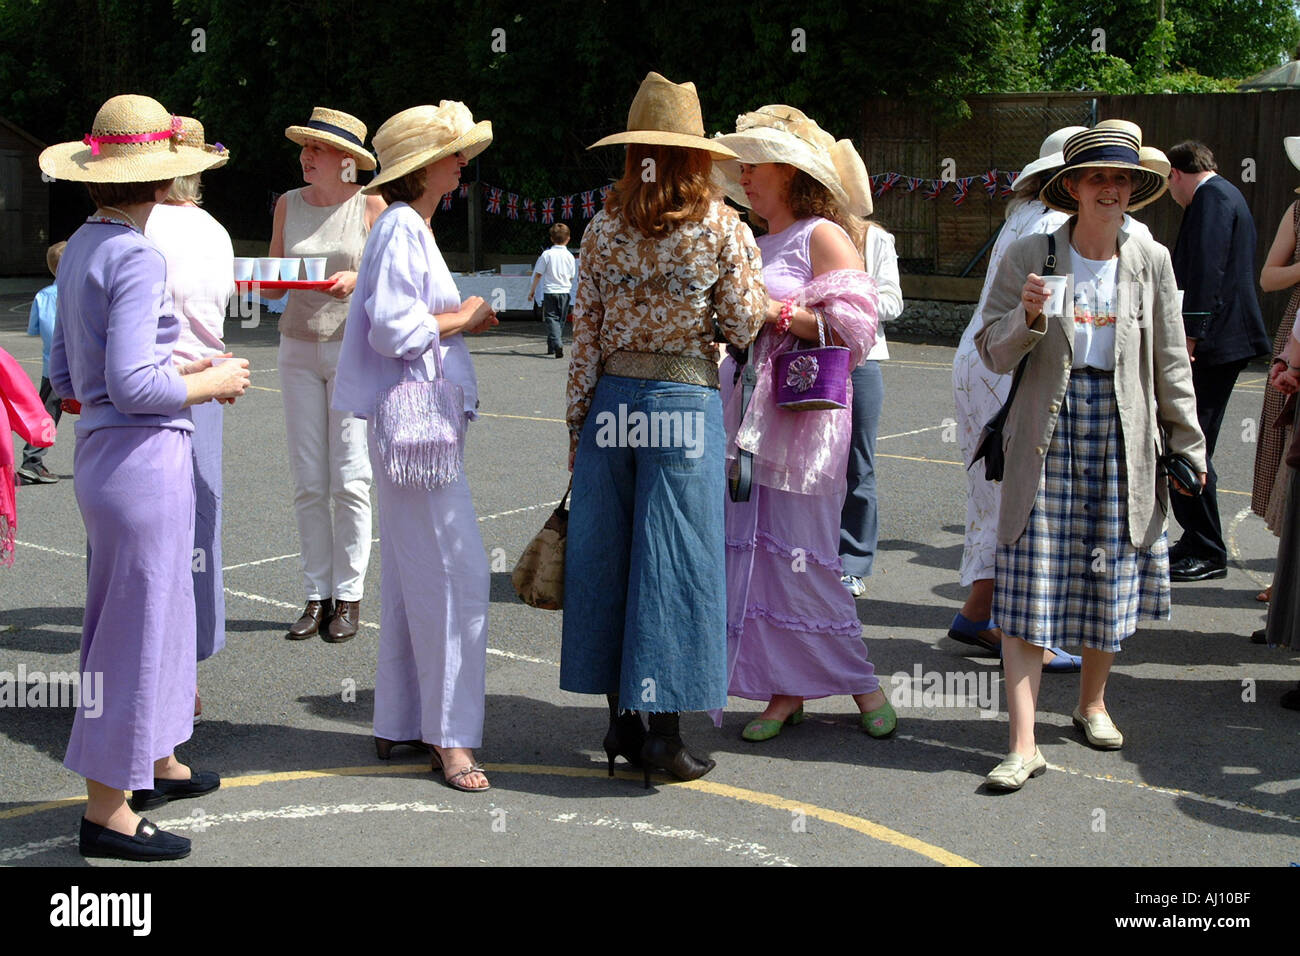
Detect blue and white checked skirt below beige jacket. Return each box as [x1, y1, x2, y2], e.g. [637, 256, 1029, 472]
[993, 368, 1169, 653]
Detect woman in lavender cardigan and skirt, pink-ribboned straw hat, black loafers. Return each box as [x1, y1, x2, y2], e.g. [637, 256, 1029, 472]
[40, 95, 248, 860]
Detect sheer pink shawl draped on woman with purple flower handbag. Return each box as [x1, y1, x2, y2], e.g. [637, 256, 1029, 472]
[722, 269, 879, 494]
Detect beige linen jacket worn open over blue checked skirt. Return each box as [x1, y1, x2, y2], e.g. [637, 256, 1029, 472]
[975, 219, 1205, 549]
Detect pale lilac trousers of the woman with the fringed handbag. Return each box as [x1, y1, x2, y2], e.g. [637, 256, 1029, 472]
[369, 433, 490, 747]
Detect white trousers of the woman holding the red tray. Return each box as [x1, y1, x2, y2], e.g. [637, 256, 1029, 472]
[278, 336, 371, 601]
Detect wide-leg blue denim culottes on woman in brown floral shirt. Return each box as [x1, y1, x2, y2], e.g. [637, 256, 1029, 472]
[560, 375, 727, 713]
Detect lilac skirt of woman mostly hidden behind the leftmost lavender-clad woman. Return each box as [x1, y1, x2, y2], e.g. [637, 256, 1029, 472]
[190, 402, 226, 661]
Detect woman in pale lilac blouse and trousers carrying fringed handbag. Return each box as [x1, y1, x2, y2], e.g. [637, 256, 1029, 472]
[333, 100, 497, 792]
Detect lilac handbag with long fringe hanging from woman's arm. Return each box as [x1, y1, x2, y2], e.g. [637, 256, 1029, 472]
[374, 342, 465, 489]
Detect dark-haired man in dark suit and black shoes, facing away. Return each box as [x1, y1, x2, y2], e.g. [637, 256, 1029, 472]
[1169, 140, 1269, 581]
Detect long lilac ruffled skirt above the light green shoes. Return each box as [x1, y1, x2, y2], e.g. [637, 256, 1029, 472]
[727, 484, 880, 701]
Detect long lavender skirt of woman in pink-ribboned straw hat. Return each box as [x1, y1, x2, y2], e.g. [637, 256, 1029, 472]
[64, 427, 195, 790]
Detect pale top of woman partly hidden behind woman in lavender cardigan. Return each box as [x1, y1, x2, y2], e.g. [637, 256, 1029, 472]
[144, 203, 235, 363]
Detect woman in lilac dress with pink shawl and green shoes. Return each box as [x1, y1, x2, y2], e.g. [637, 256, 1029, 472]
[719, 105, 898, 741]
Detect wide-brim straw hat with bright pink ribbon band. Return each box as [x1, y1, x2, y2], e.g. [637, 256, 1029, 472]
[38, 94, 221, 182]
